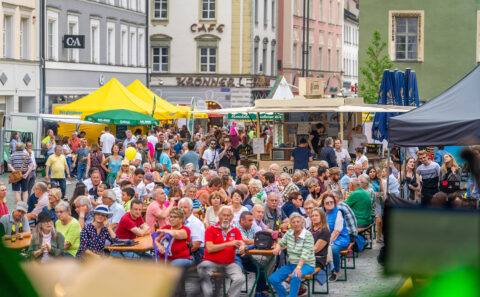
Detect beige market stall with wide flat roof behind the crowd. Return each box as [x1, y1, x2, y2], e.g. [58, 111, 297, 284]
[194, 98, 414, 171]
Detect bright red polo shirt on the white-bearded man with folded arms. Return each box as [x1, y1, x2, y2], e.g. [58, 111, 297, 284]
[203, 223, 242, 265]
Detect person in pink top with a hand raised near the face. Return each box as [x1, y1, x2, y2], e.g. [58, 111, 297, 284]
[145, 188, 175, 232]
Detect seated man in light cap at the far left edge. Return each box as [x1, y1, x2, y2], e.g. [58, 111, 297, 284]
[0, 201, 31, 240]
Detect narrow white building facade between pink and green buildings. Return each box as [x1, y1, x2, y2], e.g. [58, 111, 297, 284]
[342, 0, 359, 97]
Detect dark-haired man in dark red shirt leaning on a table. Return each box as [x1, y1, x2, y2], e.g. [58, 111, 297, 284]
[112, 199, 150, 258]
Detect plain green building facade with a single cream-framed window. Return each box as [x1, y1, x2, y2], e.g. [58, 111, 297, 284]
[359, 0, 480, 100]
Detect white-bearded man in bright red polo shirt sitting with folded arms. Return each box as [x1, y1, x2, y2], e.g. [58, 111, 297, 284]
[197, 206, 245, 297]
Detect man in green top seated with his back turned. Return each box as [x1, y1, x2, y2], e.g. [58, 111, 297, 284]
[345, 178, 372, 227]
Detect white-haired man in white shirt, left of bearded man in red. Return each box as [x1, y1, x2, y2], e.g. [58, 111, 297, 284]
[178, 197, 205, 264]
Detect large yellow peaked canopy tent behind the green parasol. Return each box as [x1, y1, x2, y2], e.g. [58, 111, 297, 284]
[53, 78, 156, 144]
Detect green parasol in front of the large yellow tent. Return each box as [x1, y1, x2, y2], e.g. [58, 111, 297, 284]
[85, 109, 159, 126]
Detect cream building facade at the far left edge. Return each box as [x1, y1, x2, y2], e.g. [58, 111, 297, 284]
[0, 0, 39, 120]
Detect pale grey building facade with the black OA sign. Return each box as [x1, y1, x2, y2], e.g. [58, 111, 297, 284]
[45, 0, 147, 113]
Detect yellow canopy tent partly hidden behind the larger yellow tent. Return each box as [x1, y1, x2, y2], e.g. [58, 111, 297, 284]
[127, 79, 189, 120]
